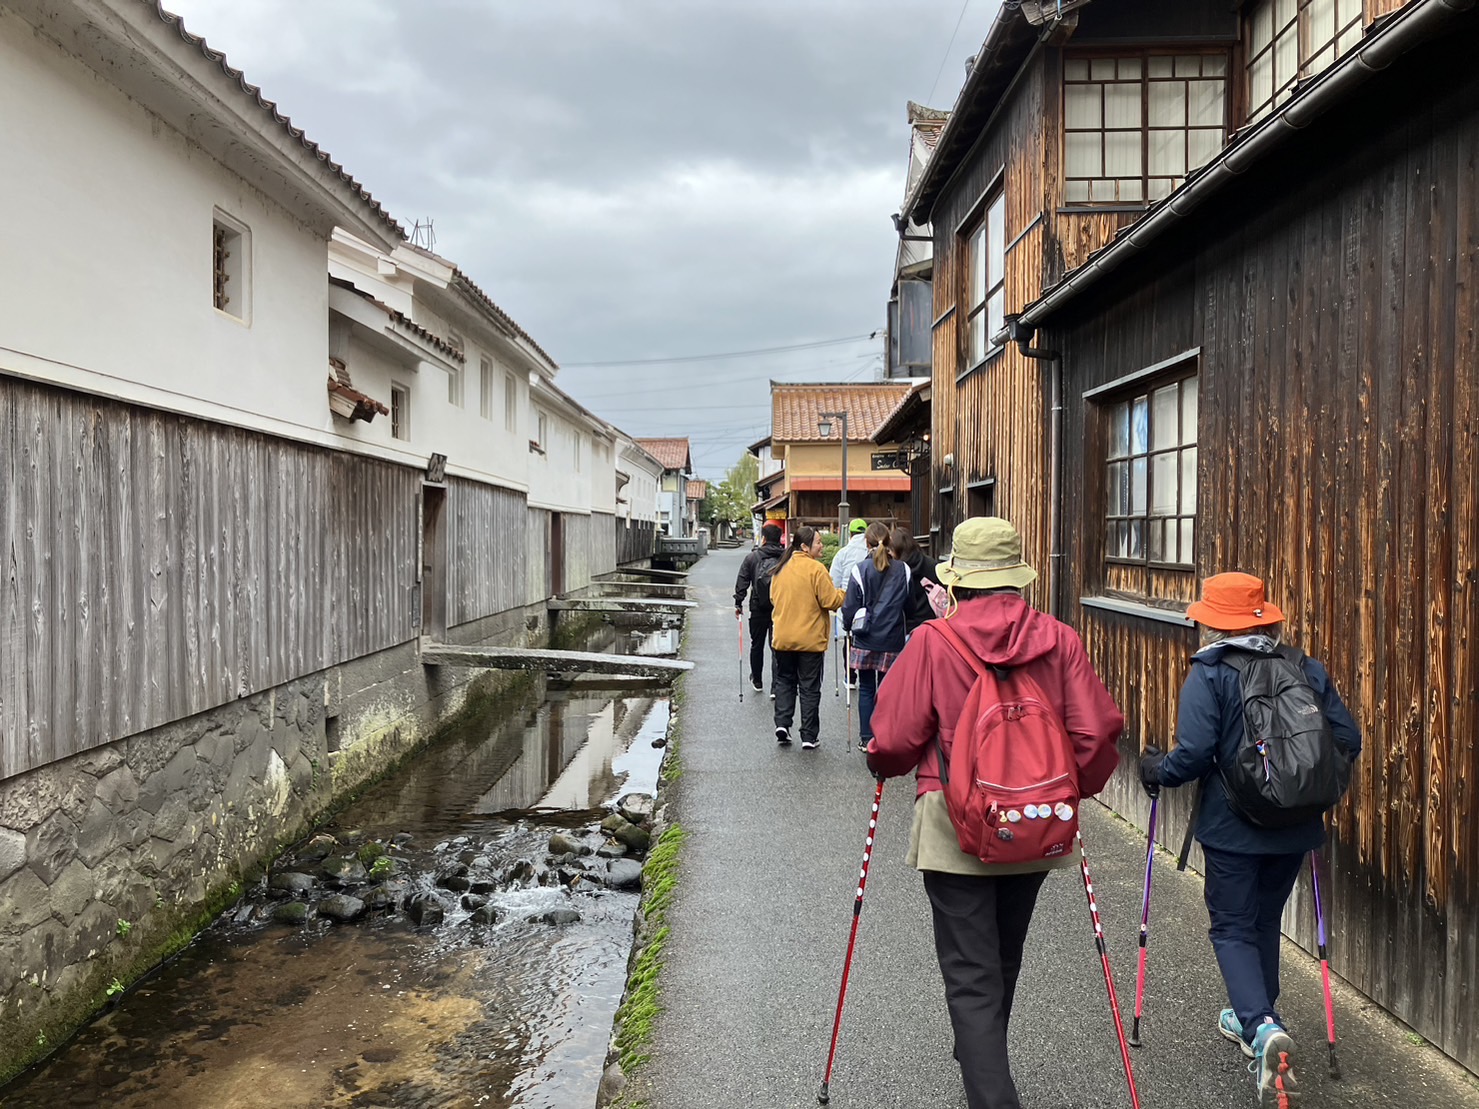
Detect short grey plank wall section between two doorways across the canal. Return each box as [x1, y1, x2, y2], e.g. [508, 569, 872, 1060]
[447, 478, 529, 627]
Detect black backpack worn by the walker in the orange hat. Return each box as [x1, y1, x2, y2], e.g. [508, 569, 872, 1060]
[1217, 646, 1350, 828]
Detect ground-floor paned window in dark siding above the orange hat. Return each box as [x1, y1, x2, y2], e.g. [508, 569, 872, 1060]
[1105, 376, 1197, 568]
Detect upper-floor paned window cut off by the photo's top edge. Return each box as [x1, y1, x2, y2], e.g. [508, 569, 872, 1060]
[1244, 0, 1365, 121]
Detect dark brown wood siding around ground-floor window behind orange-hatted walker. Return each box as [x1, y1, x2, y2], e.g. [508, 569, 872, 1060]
[1047, 44, 1479, 1068]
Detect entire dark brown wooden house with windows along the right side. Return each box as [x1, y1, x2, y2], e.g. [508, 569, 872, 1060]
[911, 0, 1479, 1069]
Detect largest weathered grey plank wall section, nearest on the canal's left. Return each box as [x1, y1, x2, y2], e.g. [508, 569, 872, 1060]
[0, 379, 420, 778]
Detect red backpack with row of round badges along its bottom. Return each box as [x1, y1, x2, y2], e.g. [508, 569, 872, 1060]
[929, 620, 1080, 865]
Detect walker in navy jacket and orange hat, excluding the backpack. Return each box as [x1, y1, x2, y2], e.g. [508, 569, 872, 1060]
[1140, 574, 1361, 1106]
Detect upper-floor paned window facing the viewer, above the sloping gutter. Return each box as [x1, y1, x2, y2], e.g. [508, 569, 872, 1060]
[1063, 50, 1228, 204]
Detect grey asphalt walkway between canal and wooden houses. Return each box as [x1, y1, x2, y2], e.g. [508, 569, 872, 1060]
[630, 552, 1479, 1109]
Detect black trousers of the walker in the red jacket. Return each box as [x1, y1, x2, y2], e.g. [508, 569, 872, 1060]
[924, 871, 1047, 1109]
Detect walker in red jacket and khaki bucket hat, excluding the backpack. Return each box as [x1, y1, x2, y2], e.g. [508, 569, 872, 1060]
[868, 516, 1124, 1109]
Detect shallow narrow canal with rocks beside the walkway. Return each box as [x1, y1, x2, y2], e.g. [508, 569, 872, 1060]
[0, 628, 677, 1109]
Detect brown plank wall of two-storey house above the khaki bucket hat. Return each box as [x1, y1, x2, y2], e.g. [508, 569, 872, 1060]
[930, 49, 1049, 569]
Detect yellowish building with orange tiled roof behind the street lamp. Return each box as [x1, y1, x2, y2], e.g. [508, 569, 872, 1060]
[757, 381, 913, 529]
